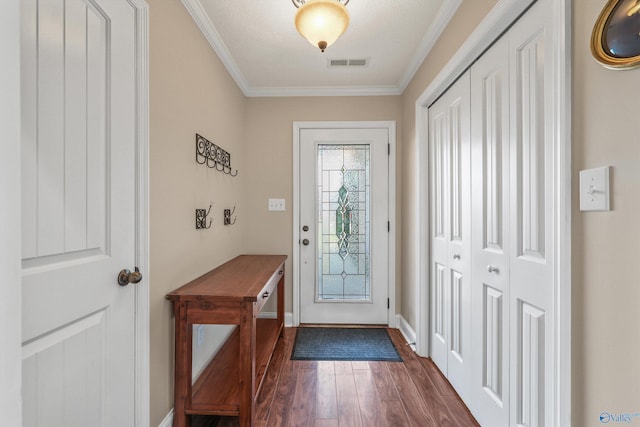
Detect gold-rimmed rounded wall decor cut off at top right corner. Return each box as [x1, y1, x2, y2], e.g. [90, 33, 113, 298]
[591, 0, 640, 70]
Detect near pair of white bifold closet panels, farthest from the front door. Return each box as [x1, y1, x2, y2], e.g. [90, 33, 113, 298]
[469, 0, 555, 427]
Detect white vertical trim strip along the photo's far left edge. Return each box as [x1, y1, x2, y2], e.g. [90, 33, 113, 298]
[0, 0, 22, 426]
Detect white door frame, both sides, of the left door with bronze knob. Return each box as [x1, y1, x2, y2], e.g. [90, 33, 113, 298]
[0, 0, 150, 427]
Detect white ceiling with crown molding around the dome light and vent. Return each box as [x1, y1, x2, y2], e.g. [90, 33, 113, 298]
[182, 0, 462, 96]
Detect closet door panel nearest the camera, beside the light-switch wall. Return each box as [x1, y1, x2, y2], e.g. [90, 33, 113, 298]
[510, 0, 555, 427]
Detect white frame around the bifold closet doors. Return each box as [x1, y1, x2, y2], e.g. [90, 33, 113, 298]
[416, 0, 572, 427]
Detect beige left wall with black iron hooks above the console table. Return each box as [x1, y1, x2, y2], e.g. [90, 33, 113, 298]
[149, 0, 248, 426]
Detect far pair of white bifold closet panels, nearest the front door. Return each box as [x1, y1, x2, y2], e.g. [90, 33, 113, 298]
[429, 72, 471, 399]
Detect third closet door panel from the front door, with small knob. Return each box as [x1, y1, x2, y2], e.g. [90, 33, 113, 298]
[469, 37, 510, 427]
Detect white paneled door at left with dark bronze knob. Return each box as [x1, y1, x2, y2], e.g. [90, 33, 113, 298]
[21, 0, 137, 427]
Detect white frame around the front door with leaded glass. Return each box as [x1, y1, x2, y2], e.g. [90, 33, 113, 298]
[291, 121, 396, 328]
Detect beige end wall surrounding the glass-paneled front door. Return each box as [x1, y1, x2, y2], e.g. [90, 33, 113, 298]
[245, 96, 401, 312]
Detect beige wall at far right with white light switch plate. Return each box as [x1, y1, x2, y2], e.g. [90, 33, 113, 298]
[572, 0, 640, 427]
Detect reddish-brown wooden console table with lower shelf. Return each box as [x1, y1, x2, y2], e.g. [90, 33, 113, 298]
[167, 255, 287, 427]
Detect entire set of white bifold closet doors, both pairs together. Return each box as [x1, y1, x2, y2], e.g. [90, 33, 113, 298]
[428, 0, 558, 427]
